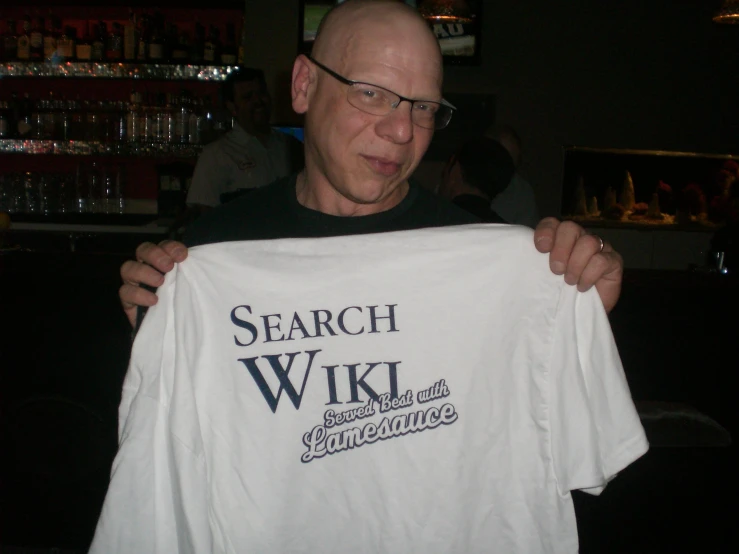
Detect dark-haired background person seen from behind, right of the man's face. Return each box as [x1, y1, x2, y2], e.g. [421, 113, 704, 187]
[439, 137, 515, 223]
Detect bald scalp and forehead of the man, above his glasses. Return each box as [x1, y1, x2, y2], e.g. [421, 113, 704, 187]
[312, 0, 442, 86]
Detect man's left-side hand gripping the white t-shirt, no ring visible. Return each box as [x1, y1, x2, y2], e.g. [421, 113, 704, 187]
[118, 240, 187, 327]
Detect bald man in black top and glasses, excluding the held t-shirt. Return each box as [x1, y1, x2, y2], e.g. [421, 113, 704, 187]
[119, 2, 623, 325]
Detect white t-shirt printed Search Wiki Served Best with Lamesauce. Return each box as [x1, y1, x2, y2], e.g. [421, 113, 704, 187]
[91, 225, 647, 554]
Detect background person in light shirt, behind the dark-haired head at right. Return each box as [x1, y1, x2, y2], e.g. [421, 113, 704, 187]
[485, 126, 539, 227]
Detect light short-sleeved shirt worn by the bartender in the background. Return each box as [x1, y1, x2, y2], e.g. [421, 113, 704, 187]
[187, 124, 290, 206]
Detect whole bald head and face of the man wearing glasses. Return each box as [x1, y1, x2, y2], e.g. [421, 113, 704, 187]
[292, 0, 442, 215]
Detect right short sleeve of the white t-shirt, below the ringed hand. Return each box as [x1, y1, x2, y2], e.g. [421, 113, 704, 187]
[549, 285, 648, 494]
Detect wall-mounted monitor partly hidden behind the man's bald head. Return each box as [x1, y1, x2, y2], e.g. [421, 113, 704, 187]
[298, 0, 483, 65]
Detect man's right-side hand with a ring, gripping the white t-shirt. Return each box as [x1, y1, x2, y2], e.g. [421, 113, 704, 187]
[534, 217, 624, 312]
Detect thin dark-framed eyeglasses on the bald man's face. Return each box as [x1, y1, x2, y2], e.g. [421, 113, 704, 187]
[308, 58, 456, 130]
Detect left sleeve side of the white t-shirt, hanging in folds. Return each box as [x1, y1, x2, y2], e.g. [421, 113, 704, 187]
[89, 271, 211, 554]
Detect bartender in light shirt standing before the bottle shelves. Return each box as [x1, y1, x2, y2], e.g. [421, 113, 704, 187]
[187, 67, 302, 213]
